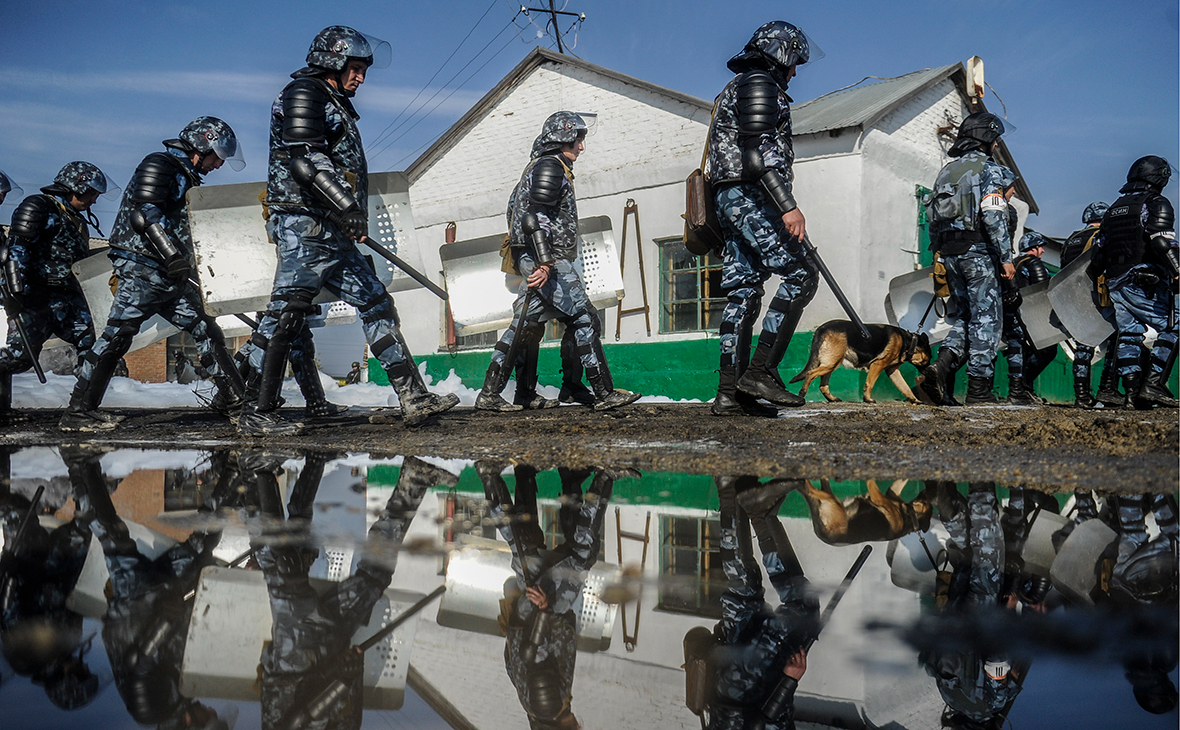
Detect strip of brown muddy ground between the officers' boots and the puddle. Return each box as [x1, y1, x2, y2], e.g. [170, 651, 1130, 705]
[0, 403, 1180, 492]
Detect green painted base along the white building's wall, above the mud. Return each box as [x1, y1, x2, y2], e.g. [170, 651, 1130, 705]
[369, 333, 1180, 403]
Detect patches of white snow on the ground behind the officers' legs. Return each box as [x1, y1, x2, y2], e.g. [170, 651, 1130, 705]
[12, 363, 701, 408]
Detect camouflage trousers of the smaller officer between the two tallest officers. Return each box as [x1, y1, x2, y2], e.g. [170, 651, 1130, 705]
[492, 254, 614, 387]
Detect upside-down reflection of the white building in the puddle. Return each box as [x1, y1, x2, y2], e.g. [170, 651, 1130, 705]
[369, 468, 940, 729]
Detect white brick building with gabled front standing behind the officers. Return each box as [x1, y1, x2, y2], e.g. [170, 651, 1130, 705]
[398, 48, 1037, 397]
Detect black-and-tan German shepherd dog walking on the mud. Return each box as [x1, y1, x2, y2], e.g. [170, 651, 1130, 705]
[791, 320, 930, 403]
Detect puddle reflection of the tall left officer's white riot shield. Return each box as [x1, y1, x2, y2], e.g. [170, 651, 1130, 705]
[181, 567, 424, 710]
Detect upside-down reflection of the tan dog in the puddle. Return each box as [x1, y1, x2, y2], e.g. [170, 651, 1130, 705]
[797, 479, 932, 545]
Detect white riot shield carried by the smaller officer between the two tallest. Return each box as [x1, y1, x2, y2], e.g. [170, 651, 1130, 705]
[439, 216, 624, 337]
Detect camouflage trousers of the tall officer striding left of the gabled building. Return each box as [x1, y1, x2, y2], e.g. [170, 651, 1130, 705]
[248, 213, 414, 373]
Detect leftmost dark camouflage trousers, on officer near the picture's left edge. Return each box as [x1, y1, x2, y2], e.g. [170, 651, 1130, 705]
[0, 288, 94, 373]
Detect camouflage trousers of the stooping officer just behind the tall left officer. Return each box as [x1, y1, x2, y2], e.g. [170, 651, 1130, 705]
[78, 256, 232, 391]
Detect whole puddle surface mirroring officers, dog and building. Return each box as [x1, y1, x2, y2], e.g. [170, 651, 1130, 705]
[0, 446, 1178, 728]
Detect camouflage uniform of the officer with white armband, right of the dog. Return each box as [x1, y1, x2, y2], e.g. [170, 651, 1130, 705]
[931, 150, 1015, 379]
